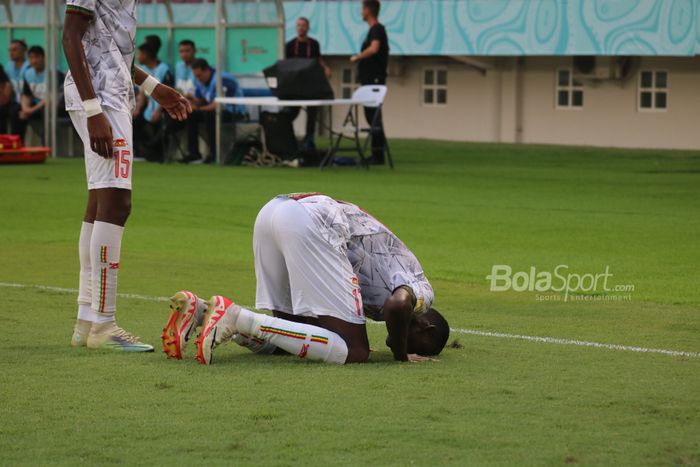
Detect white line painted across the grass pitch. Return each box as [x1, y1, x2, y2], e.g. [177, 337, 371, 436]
[0, 282, 700, 358]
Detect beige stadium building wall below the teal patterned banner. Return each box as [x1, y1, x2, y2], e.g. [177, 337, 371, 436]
[320, 56, 700, 149]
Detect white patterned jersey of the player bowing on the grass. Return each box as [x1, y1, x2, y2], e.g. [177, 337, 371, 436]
[283, 193, 434, 320]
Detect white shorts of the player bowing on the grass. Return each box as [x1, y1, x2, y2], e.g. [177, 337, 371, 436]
[253, 198, 365, 324]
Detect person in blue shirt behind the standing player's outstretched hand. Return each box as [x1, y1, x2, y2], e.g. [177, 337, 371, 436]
[134, 41, 173, 162]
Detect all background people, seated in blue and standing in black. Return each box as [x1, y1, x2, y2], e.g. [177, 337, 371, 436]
[0, 0, 389, 164]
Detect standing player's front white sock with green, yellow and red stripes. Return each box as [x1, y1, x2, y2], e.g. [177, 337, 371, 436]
[90, 221, 124, 323]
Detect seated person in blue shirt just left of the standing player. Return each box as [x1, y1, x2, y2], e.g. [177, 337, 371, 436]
[13, 45, 64, 144]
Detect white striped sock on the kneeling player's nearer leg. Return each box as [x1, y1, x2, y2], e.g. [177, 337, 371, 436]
[235, 308, 348, 365]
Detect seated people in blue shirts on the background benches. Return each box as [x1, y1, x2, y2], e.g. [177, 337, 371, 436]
[0, 35, 245, 162]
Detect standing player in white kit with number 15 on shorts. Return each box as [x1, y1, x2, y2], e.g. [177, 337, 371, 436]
[63, 0, 191, 352]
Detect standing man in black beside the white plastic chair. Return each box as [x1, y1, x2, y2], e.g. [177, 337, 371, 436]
[350, 0, 389, 165]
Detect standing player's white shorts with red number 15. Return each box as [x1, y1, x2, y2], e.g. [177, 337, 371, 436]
[68, 107, 134, 190]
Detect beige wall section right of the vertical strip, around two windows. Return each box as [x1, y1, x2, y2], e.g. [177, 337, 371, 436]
[523, 57, 700, 149]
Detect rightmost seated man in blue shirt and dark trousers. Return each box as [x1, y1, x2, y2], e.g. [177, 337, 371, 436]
[183, 58, 245, 163]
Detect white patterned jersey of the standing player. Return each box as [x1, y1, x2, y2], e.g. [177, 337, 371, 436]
[64, 0, 136, 113]
